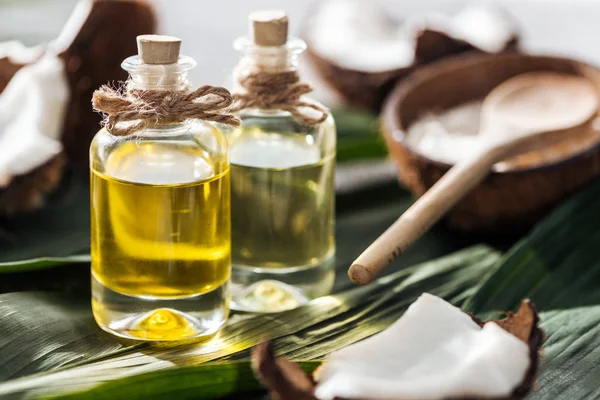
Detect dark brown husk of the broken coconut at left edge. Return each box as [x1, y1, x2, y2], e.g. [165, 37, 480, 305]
[0, 0, 156, 216]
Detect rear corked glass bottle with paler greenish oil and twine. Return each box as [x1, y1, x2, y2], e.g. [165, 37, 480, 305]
[228, 11, 336, 312]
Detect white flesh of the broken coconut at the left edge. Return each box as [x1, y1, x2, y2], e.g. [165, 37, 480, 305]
[0, 0, 92, 189]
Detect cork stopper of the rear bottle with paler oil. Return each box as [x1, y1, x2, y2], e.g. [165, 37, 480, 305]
[248, 10, 288, 47]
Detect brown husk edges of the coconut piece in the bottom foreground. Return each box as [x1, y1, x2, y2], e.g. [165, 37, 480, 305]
[252, 300, 544, 400]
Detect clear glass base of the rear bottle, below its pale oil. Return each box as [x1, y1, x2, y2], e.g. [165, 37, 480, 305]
[230, 255, 335, 313]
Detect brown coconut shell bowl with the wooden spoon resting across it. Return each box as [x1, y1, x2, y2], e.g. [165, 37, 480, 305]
[382, 53, 600, 235]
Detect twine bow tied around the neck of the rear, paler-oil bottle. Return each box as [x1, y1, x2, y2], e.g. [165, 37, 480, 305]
[233, 71, 328, 125]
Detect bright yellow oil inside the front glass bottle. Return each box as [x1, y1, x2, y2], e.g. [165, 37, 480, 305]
[91, 143, 230, 298]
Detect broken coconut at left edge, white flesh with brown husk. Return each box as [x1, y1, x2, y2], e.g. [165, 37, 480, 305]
[0, 0, 156, 215]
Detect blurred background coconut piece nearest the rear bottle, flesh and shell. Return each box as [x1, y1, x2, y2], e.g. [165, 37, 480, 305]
[302, 0, 414, 109]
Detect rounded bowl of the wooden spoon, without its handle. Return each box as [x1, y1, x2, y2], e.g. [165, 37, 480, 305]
[478, 72, 599, 161]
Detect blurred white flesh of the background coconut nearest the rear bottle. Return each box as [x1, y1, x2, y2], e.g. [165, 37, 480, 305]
[306, 0, 414, 72]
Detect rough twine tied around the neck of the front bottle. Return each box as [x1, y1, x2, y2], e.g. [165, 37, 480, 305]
[92, 85, 240, 136]
